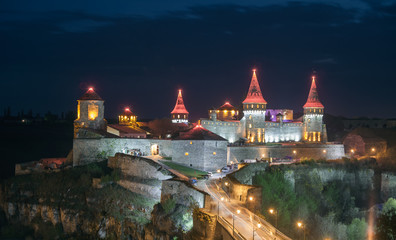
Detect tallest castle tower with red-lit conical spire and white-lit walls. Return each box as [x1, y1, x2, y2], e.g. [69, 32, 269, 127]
[243, 69, 267, 143]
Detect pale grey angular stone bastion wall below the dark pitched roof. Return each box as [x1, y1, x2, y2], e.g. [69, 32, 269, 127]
[172, 140, 228, 171]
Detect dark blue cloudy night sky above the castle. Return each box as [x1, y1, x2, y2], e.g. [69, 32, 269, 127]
[0, 0, 396, 120]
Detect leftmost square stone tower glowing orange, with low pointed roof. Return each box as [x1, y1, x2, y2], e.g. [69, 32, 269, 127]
[74, 88, 107, 137]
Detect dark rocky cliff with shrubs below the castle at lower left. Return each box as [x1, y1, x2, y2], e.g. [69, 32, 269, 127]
[0, 159, 175, 239]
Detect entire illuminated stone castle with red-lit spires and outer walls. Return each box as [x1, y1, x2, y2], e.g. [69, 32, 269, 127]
[73, 70, 345, 171]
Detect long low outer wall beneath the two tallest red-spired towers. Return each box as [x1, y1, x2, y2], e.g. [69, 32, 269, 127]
[227, 144, 345, 162]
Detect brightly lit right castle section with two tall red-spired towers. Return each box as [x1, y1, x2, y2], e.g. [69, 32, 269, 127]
[200, 70, 327, 144]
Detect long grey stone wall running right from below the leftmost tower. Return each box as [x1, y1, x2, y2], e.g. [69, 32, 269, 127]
[73, 138, 172, 166]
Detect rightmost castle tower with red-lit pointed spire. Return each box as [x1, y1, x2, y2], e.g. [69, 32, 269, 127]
[303, 75, 327, 142]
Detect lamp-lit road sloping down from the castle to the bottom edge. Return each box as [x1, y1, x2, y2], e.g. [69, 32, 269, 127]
[198, 179, 290, 240]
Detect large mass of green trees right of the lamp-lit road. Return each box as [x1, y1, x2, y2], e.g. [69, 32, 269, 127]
[253, 166, 367, 239]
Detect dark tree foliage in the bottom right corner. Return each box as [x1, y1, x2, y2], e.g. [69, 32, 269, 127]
[376, 198, 396, 240]
